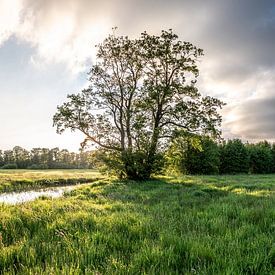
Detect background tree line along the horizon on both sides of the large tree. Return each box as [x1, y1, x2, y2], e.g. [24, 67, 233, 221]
[0, 140, 275, 174]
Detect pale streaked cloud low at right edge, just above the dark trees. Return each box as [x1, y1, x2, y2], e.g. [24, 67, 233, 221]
[224, 70, 275, 141]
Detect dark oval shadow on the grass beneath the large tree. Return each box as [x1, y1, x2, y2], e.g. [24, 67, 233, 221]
[95, 179, 229, 208]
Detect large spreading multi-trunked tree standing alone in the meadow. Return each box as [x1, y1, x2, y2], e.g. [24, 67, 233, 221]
[54, 30, 223, 179]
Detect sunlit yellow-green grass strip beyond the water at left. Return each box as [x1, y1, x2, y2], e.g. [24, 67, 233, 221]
[0, 169, 102, 193]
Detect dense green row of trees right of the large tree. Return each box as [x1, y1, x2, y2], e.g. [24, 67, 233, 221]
[165, 136, 275, 174]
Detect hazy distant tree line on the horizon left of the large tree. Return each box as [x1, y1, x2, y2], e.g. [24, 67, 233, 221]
[0, 146, 98, 169]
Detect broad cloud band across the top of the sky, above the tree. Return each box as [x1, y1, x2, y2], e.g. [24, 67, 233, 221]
[0, 0, 275, 75]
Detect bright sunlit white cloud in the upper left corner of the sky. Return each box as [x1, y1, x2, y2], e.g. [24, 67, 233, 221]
[0, 0, 114, 72]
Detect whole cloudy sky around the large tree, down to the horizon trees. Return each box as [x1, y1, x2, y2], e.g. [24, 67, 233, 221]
[0, 0, 275, 151]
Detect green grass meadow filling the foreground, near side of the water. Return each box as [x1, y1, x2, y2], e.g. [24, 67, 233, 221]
[0, 172, 275, 274]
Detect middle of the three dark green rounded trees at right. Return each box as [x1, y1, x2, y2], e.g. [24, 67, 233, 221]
[220, 139, 249, 174]
